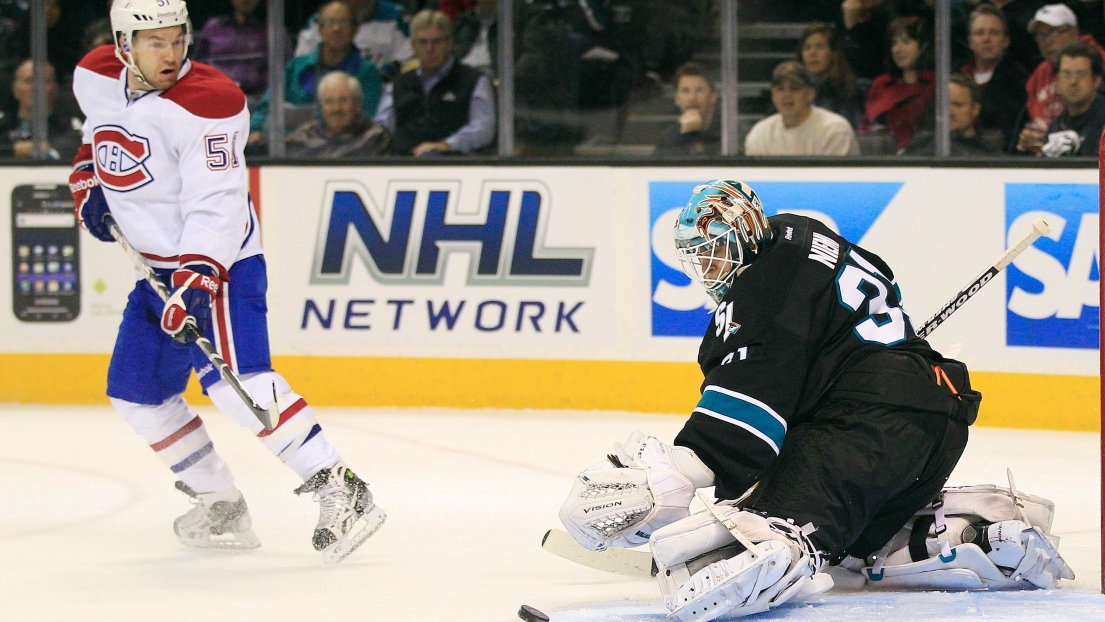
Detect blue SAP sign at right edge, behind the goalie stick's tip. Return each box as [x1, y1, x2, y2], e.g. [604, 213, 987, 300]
[1006, 183, 1101, 349]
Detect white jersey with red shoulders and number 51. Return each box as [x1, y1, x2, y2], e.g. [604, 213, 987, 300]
[73, 45, 261, 277]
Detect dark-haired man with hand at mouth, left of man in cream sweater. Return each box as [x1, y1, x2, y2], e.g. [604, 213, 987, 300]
[653, 62, 722, 156]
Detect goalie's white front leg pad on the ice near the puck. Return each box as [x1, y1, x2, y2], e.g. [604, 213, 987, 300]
[650, 502, 833, 622]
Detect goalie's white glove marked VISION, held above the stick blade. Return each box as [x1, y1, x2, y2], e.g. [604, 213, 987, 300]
[560, 431, 714, 550]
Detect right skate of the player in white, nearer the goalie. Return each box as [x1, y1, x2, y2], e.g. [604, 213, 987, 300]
[295, 463, 387, 563]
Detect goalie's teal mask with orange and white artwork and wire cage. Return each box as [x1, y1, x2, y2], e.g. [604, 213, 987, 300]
[675, 179, 772, 303]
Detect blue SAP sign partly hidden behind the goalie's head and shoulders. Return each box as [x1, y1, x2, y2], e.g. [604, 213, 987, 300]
[649, 181, 903, 337]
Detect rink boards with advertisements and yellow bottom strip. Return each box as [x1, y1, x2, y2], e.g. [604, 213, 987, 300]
[0, 167, 1099, 430]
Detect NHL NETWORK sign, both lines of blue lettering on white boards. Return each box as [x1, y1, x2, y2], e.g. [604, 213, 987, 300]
[301, 180, 594, 333]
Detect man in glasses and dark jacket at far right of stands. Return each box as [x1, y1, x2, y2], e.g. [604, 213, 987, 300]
[1041, 41, 1105, 158]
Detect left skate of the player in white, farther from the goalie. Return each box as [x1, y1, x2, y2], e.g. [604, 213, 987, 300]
[172, 482, 261, 550]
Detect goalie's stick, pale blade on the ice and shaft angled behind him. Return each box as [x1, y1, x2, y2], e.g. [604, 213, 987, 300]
[541, 219, 1051, 578]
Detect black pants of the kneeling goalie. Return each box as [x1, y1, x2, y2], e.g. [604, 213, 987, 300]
[743, 355, 981, 559]
